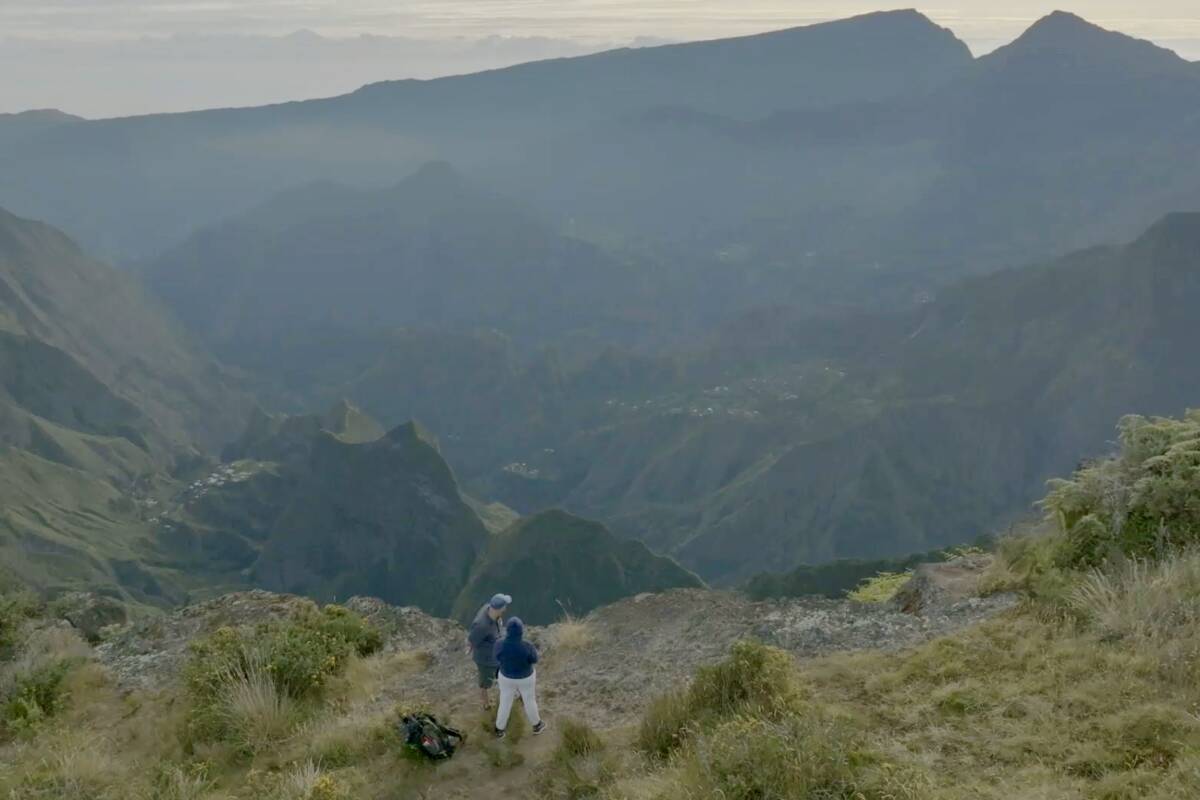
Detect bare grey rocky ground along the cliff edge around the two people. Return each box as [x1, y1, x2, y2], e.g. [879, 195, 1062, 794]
[97, 559, 1015, 728]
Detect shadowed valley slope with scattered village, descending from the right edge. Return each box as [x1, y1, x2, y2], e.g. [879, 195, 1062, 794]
[288, 213, 1200, 583]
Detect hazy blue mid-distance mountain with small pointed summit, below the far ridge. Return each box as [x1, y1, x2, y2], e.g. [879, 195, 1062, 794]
[146, 163, 653, 366]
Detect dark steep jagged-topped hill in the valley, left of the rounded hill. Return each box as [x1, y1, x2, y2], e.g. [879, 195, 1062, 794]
[253, 425, 488, 614]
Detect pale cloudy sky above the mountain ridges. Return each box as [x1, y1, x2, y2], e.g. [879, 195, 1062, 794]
[0, 0, 1200, 116]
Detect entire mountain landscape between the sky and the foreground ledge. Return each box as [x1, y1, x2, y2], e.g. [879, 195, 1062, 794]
[0, 6, 1200, 609]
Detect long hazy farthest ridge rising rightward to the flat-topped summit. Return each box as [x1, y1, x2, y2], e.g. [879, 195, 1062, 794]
[0, 12, 971, 259]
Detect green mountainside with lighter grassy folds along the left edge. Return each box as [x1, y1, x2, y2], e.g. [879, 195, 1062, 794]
[0, 211, 245, 603]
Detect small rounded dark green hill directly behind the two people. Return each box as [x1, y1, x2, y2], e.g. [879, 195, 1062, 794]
[454, 511, 703, 625]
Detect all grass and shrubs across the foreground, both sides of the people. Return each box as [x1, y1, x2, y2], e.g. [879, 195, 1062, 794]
[0, 414, 1200, 800]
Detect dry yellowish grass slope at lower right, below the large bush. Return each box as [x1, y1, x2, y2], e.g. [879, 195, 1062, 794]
[614, 554, 1200, 800]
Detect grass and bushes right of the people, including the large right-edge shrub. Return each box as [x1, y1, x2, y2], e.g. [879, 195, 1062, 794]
[547, 413, 1200, 800]
